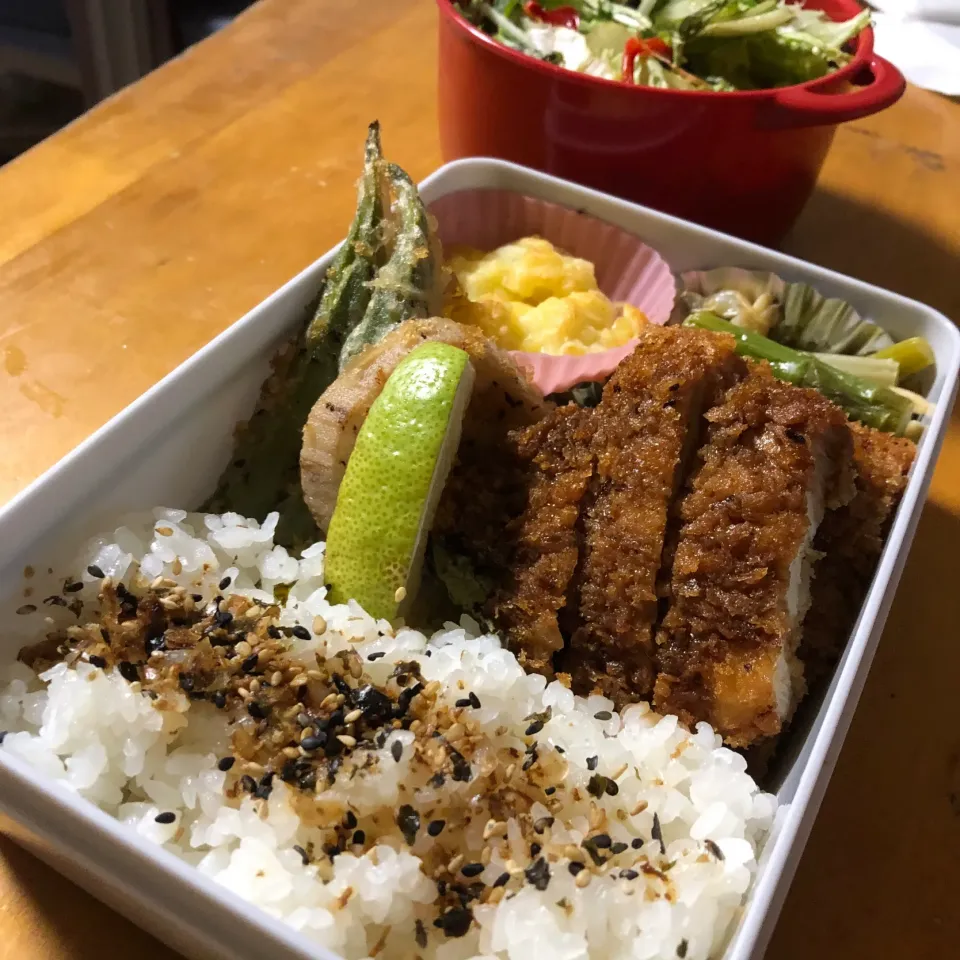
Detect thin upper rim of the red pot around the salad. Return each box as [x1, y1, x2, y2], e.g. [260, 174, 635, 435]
[437, 0, 873, 101]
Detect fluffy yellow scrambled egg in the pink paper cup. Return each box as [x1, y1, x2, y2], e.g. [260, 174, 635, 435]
[447, 237, 647, 355]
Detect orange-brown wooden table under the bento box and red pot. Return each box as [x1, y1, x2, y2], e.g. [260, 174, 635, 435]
[0, 0, 960, 960]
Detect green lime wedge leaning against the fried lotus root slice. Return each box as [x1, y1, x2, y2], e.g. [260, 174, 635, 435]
[325, 342, 474, 620]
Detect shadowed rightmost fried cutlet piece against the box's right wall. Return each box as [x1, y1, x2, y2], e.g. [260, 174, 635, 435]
[800, 423, 917, 683]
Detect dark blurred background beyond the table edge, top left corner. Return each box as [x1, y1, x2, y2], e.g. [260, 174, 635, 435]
[0, 0, 253, 164]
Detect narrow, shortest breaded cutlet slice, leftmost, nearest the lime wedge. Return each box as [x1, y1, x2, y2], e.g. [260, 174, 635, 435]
[488, 404, 594, 677]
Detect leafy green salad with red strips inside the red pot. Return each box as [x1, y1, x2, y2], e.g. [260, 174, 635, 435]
[454, 0, 870, 90]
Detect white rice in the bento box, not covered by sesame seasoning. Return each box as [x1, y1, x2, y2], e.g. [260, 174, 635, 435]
[0, 509, 776, 960]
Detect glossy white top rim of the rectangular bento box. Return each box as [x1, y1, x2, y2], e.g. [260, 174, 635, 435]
[0, 158, 960, 960]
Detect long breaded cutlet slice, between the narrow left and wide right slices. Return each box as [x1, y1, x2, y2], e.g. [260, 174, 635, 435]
[565, 326, 746, 707]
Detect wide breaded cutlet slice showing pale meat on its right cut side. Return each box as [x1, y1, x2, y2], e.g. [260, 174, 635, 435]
[654, 365, 853, 747]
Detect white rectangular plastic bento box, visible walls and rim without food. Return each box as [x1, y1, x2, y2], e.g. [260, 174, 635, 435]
[0, 159, 960, 960]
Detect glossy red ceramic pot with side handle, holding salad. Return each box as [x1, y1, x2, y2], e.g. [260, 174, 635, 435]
[437, 0, 906, 244]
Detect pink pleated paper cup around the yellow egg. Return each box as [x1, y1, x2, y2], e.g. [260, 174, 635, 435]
[429, 189, 677, 394]
